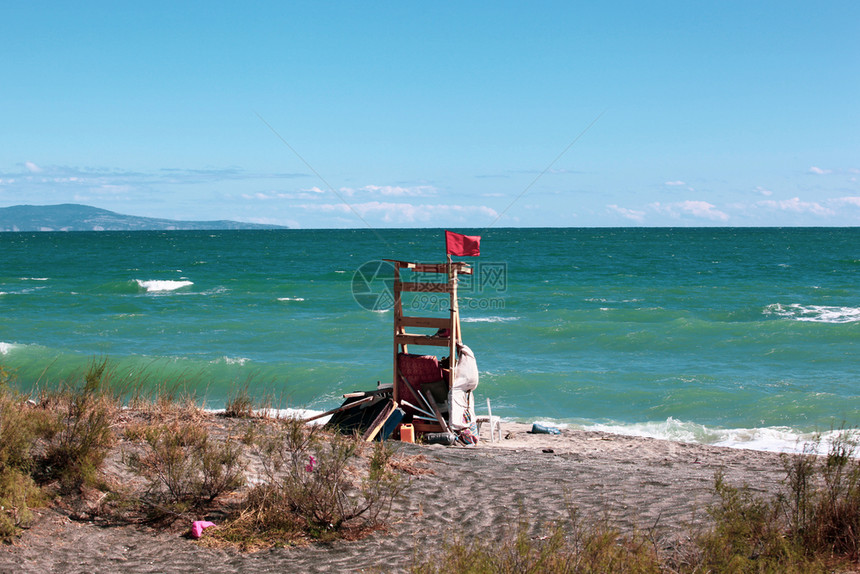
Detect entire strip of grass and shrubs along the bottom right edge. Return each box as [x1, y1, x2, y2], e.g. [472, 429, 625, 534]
[410, 432, 860, 574]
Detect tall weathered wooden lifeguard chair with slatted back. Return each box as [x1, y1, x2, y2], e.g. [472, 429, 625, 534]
[387, 256, 474, 433]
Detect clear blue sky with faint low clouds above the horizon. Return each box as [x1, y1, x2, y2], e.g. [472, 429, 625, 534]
[0, 0, 860, 228]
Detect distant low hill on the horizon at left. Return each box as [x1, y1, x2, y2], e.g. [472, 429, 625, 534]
[0, 203, 285, 232]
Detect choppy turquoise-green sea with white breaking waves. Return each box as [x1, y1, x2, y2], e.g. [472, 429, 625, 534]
[0, 228, 860, 451]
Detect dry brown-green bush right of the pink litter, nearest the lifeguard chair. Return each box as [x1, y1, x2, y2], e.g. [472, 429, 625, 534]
[214, 418, 404, 547]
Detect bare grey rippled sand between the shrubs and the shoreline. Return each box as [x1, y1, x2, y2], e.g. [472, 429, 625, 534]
[0, 416, 784, 574]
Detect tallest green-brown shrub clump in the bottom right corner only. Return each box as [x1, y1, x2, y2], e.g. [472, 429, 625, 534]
[698, 429, 860, 573]
